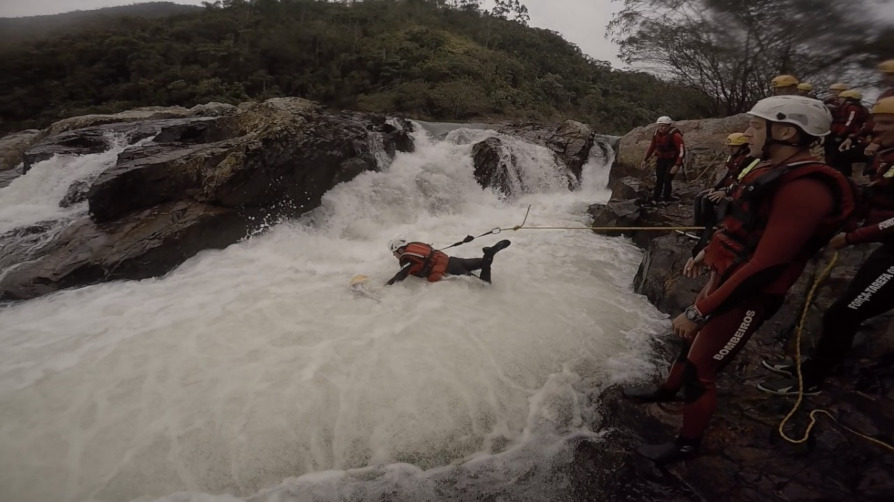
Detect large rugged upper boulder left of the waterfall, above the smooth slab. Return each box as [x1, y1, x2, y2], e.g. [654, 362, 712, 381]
[88, 104, 409, 222]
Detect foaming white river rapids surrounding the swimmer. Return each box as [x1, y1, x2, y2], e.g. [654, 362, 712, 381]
[0, 125, 666, 502]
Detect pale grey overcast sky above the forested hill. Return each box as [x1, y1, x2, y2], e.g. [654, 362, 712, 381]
[0, 0, 632, 67]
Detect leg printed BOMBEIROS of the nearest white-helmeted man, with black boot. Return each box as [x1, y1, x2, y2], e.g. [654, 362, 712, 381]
[637, 296, 781, 463]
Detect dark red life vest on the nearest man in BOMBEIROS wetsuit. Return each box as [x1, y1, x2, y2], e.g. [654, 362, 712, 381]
[705, 160, 856, 284]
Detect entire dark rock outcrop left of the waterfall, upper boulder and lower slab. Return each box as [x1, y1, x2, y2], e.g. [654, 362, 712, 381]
[0, 98, 412, 300]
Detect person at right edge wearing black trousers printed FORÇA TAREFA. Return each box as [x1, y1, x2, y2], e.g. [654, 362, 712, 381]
[758, 96, 894, 395]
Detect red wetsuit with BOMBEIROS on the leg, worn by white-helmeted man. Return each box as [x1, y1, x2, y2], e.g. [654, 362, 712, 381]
[663, 158, 854, 439]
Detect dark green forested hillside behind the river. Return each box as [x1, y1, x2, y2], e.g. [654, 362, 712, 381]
[0, 0, 709, 133]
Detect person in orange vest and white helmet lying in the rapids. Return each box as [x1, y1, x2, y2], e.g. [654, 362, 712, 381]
[385, 235, 510, 286]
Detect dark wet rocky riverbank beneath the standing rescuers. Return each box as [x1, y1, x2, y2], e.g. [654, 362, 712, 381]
[591, 117, 894, 502]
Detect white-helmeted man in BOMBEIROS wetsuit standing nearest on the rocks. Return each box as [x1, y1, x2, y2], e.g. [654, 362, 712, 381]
[624, 96, 855, 463]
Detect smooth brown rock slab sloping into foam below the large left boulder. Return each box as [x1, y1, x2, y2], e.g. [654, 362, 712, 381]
[0, 201, 248, 300]
